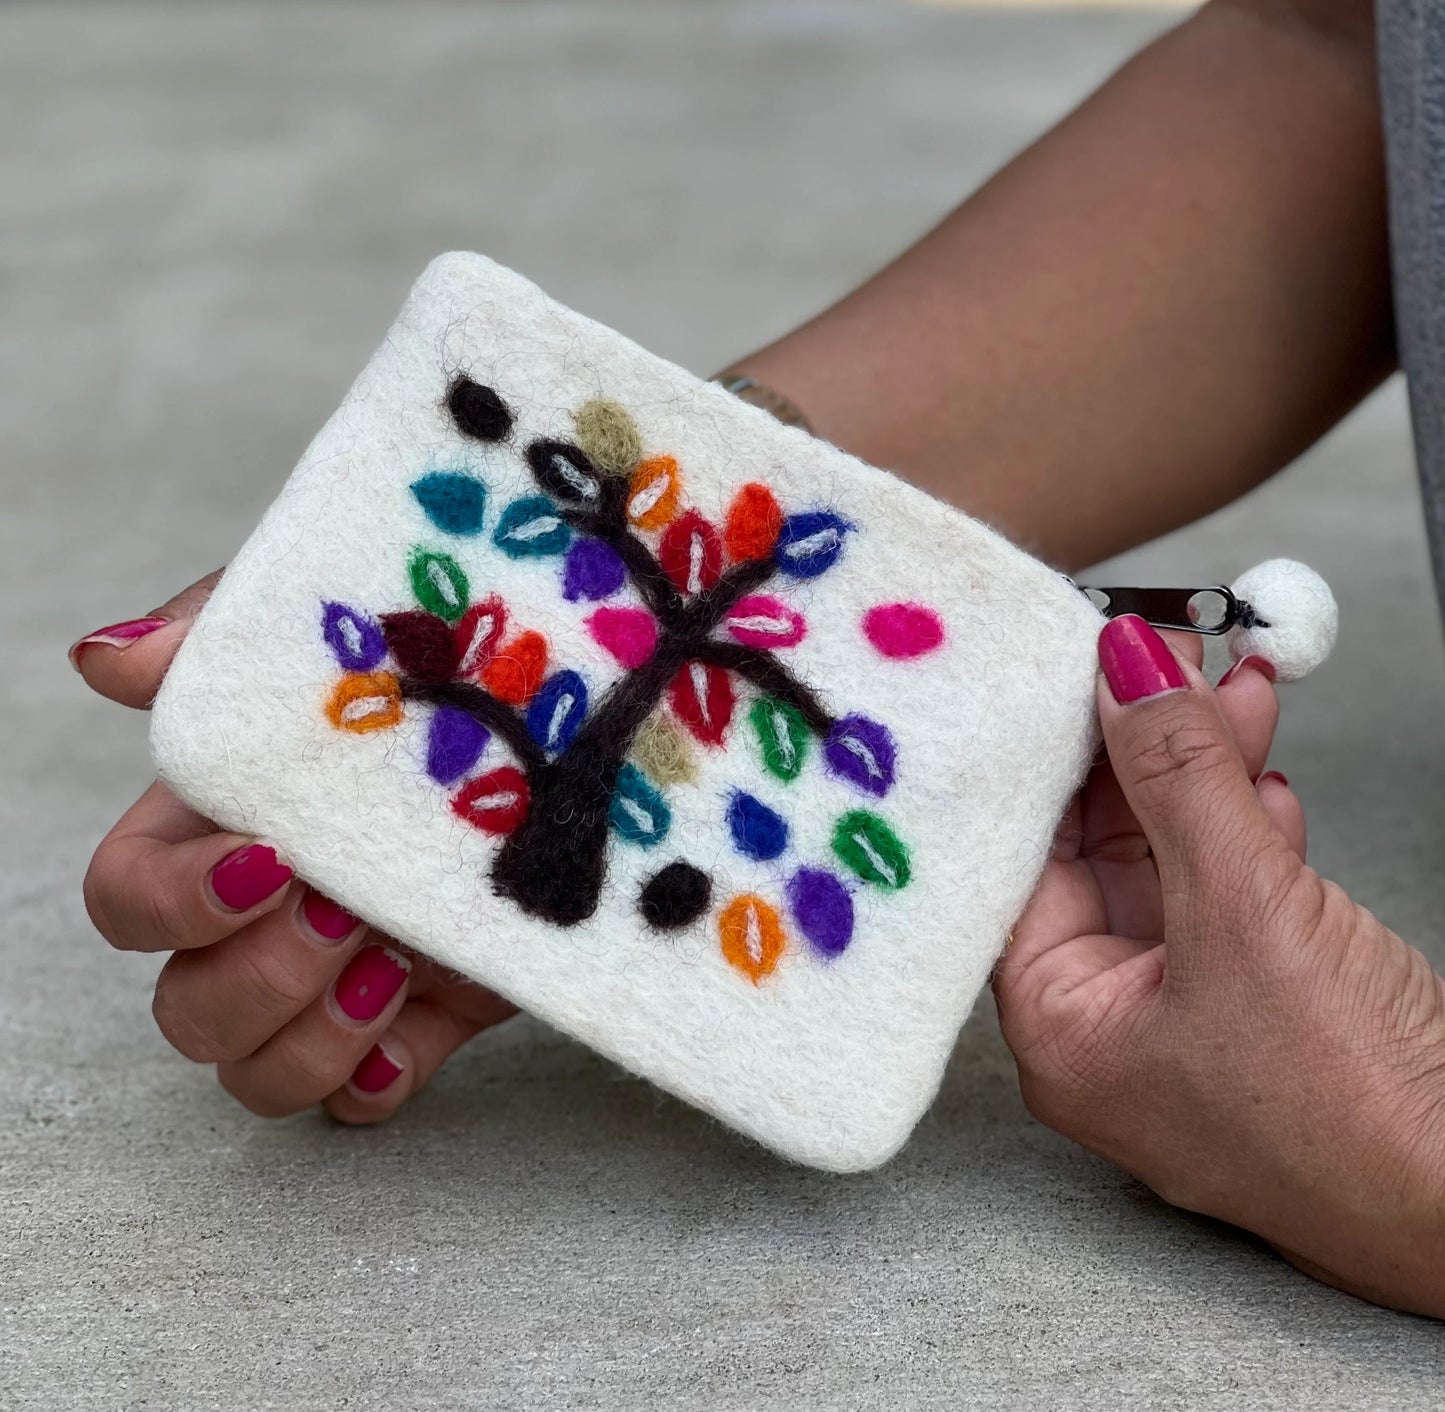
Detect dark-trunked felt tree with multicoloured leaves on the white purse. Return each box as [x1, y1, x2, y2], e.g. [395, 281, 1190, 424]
[321, 377, 919, 983]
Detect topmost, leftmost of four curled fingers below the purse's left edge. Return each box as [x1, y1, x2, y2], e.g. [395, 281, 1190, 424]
[84, 780, 295, 951]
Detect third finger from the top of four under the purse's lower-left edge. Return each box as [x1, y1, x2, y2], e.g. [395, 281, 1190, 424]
[217, 942, 412, 1117]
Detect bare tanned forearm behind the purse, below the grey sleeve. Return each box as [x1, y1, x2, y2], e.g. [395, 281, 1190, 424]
[733, 0, 1393, 568]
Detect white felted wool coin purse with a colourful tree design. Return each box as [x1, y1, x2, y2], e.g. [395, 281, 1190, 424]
[152, 254, 1335, 1171]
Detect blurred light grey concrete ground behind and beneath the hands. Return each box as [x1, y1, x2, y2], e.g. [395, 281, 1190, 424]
[0, 0, 1445, 1412]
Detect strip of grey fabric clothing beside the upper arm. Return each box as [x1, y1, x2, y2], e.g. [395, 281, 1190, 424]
[1377, 0, 1445, 604]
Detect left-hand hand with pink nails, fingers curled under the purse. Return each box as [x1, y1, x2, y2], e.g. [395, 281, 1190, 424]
[71, 574, 516, 1123]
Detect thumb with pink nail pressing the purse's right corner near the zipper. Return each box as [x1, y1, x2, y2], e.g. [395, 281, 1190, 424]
[1098, 617, 1289, 922]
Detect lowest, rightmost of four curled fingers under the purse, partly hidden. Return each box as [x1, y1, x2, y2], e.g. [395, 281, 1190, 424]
[325, 991, 516, 1123]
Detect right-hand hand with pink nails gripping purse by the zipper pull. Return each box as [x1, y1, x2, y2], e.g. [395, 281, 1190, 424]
[994, 619, 1445, 1317]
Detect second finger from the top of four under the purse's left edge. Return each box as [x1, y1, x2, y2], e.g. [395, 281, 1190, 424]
[152, 887, 367, 1064]
